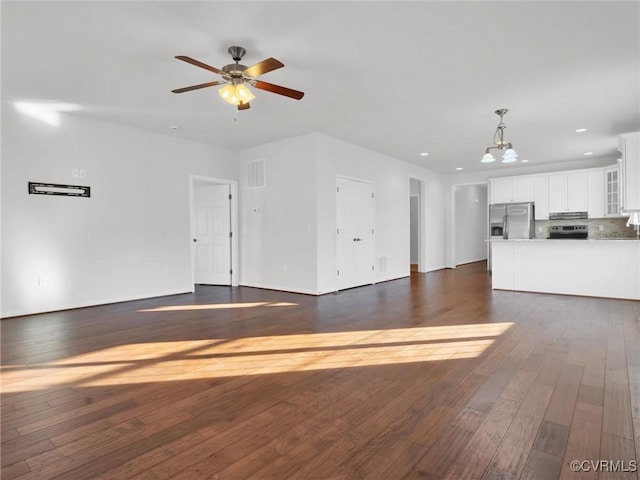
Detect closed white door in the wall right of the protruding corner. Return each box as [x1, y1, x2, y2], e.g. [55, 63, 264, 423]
[336, 177, 375, 290]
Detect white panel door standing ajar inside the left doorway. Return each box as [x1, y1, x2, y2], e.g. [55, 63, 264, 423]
[193, 183, 231, 285]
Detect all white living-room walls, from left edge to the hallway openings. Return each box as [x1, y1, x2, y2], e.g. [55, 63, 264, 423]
[0, 105, 448, 317]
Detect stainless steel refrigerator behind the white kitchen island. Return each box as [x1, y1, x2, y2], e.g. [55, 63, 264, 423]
[488, 202, 535, 270]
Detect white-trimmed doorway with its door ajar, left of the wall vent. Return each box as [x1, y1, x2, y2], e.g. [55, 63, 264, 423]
[190, 175, 239, 286]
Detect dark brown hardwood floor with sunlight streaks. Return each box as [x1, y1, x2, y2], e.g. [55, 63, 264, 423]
[0, 263, 640, 480]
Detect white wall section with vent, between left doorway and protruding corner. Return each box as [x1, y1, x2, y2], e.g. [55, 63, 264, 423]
[239, 135, 318, 294]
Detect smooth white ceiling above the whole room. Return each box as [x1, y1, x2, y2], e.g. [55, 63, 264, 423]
[2, 0, 640, 173]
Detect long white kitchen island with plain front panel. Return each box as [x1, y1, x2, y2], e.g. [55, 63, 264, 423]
[491, 239, 640, 300]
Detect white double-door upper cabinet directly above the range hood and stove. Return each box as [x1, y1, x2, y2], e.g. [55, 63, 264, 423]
[549, 171, 589, 212]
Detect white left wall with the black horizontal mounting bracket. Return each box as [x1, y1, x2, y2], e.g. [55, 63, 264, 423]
[1, 104, 237, 316]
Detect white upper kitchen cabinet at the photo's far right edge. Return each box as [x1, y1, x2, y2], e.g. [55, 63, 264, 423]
[618, 132, 640, 210]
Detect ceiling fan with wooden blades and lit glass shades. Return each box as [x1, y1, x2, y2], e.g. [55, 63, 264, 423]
[171, 45, 304, 110]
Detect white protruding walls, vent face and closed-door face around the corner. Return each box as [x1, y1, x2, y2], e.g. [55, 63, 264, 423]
[239, 133, 446, 294]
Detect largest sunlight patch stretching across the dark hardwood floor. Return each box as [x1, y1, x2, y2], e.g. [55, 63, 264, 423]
[2, 322, 512, 392]
